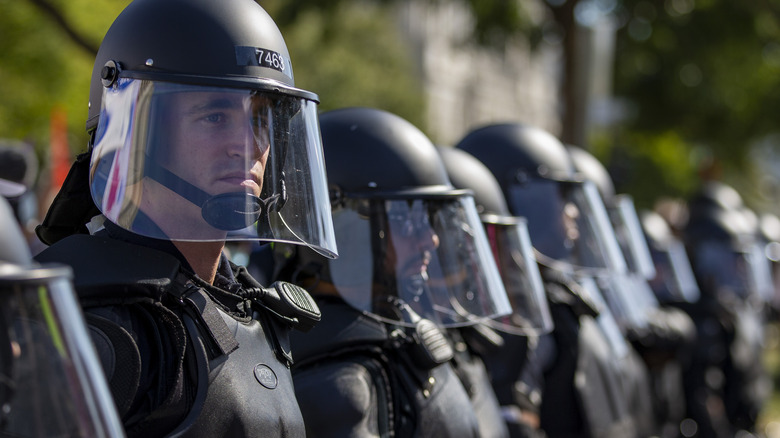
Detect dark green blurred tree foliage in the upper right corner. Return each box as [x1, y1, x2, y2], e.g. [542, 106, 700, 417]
[615, 0, 780, 175]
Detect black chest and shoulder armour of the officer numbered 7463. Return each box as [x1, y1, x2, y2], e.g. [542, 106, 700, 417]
[37, 235, 310, 437]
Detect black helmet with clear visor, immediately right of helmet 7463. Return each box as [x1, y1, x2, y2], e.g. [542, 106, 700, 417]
[298, 108, 511, 326]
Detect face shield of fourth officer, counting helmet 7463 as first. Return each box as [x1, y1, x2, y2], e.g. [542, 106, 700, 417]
[507, 179, 625, 272]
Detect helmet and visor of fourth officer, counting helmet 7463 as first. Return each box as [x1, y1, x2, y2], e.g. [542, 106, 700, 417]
[455, 123, 625, 270]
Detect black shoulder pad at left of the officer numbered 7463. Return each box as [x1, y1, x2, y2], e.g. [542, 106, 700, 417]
[35, 234, 180, 299]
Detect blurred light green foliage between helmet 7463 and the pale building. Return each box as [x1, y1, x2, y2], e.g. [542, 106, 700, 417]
[263, 1, 425, 130]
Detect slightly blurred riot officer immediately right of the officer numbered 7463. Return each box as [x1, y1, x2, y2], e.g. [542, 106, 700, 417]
[268, 108, 511, 437]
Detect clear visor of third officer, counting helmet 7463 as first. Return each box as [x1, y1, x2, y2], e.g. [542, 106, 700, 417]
[482, 215, 553, 335]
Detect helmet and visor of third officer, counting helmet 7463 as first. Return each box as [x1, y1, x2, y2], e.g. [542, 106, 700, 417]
[438, 147, 553, 335]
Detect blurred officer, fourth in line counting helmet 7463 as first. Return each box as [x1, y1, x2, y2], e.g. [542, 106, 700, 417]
[456, 124, 636, 437]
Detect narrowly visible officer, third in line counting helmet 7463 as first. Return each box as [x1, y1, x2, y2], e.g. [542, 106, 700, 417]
[439, 147, 553, 437]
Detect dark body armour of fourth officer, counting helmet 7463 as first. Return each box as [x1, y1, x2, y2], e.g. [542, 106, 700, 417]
[540, 266, 636, 438]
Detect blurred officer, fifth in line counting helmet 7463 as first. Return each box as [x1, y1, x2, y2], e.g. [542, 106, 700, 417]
[568, 146, 695, 436]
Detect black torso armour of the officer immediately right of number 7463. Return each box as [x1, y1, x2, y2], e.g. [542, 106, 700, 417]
[291, 297, 479, 438]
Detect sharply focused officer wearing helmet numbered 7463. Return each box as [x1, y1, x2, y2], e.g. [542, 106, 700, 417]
[32, 0, 336, 437]
